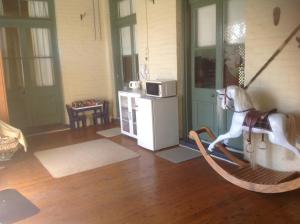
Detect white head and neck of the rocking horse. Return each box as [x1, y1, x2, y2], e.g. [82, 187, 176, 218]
[217, 86, 252, 110]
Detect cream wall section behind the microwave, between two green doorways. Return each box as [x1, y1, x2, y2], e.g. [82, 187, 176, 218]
[136, 0, 183, 134]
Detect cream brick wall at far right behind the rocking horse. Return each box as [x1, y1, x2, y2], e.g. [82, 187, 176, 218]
[246, 0, 300, 170]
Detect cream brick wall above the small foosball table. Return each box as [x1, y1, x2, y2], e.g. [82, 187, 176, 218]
[55, 0, 114, 121]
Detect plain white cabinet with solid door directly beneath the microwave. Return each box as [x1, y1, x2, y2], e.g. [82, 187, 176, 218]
[137, 97, 179, 151]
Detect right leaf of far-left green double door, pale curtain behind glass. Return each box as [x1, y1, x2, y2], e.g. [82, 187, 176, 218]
[23, 26, 62, 126]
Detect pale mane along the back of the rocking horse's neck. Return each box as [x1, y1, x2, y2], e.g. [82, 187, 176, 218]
[229, 86, 253, 111]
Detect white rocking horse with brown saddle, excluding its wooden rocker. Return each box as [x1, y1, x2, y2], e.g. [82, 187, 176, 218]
[208, 86, 300, 158]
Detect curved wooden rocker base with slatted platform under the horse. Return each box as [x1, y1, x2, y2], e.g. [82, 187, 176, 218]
[189, 127, 300, 193]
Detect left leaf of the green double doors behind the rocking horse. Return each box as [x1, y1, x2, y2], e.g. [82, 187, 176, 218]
[191, 0, 221, 138]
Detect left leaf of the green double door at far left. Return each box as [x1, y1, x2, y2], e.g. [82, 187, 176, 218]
[0, 26, 31, 127]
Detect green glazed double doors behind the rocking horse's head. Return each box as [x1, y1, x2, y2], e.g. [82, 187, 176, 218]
[189, 0, 246, 149]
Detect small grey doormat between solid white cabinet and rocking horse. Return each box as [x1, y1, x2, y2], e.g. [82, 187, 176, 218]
[156, 146, 201, 163]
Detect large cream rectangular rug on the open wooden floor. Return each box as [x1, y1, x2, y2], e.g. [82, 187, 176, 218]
[34, 139, 139, 178]
